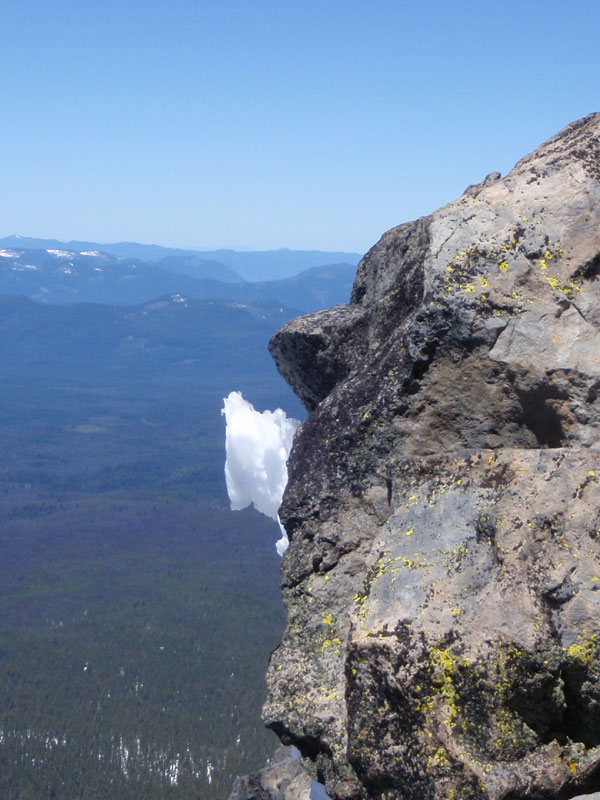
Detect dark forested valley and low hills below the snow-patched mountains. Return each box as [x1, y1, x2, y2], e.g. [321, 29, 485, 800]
[0, 296, 302, 800]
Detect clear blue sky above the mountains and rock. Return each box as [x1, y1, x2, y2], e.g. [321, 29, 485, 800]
[0, 0, 600, 252]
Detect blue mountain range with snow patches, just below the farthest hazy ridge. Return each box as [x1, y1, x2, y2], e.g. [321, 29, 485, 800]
[0, 247, 355, 313]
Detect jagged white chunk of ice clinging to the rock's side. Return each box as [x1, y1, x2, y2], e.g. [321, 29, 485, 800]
[221, 392, 300, 556]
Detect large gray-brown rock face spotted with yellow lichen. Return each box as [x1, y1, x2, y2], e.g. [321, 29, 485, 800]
[264, 114, 600, 800]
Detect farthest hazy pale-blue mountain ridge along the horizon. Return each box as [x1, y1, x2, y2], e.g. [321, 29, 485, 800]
[0, 235, 361, 281]
